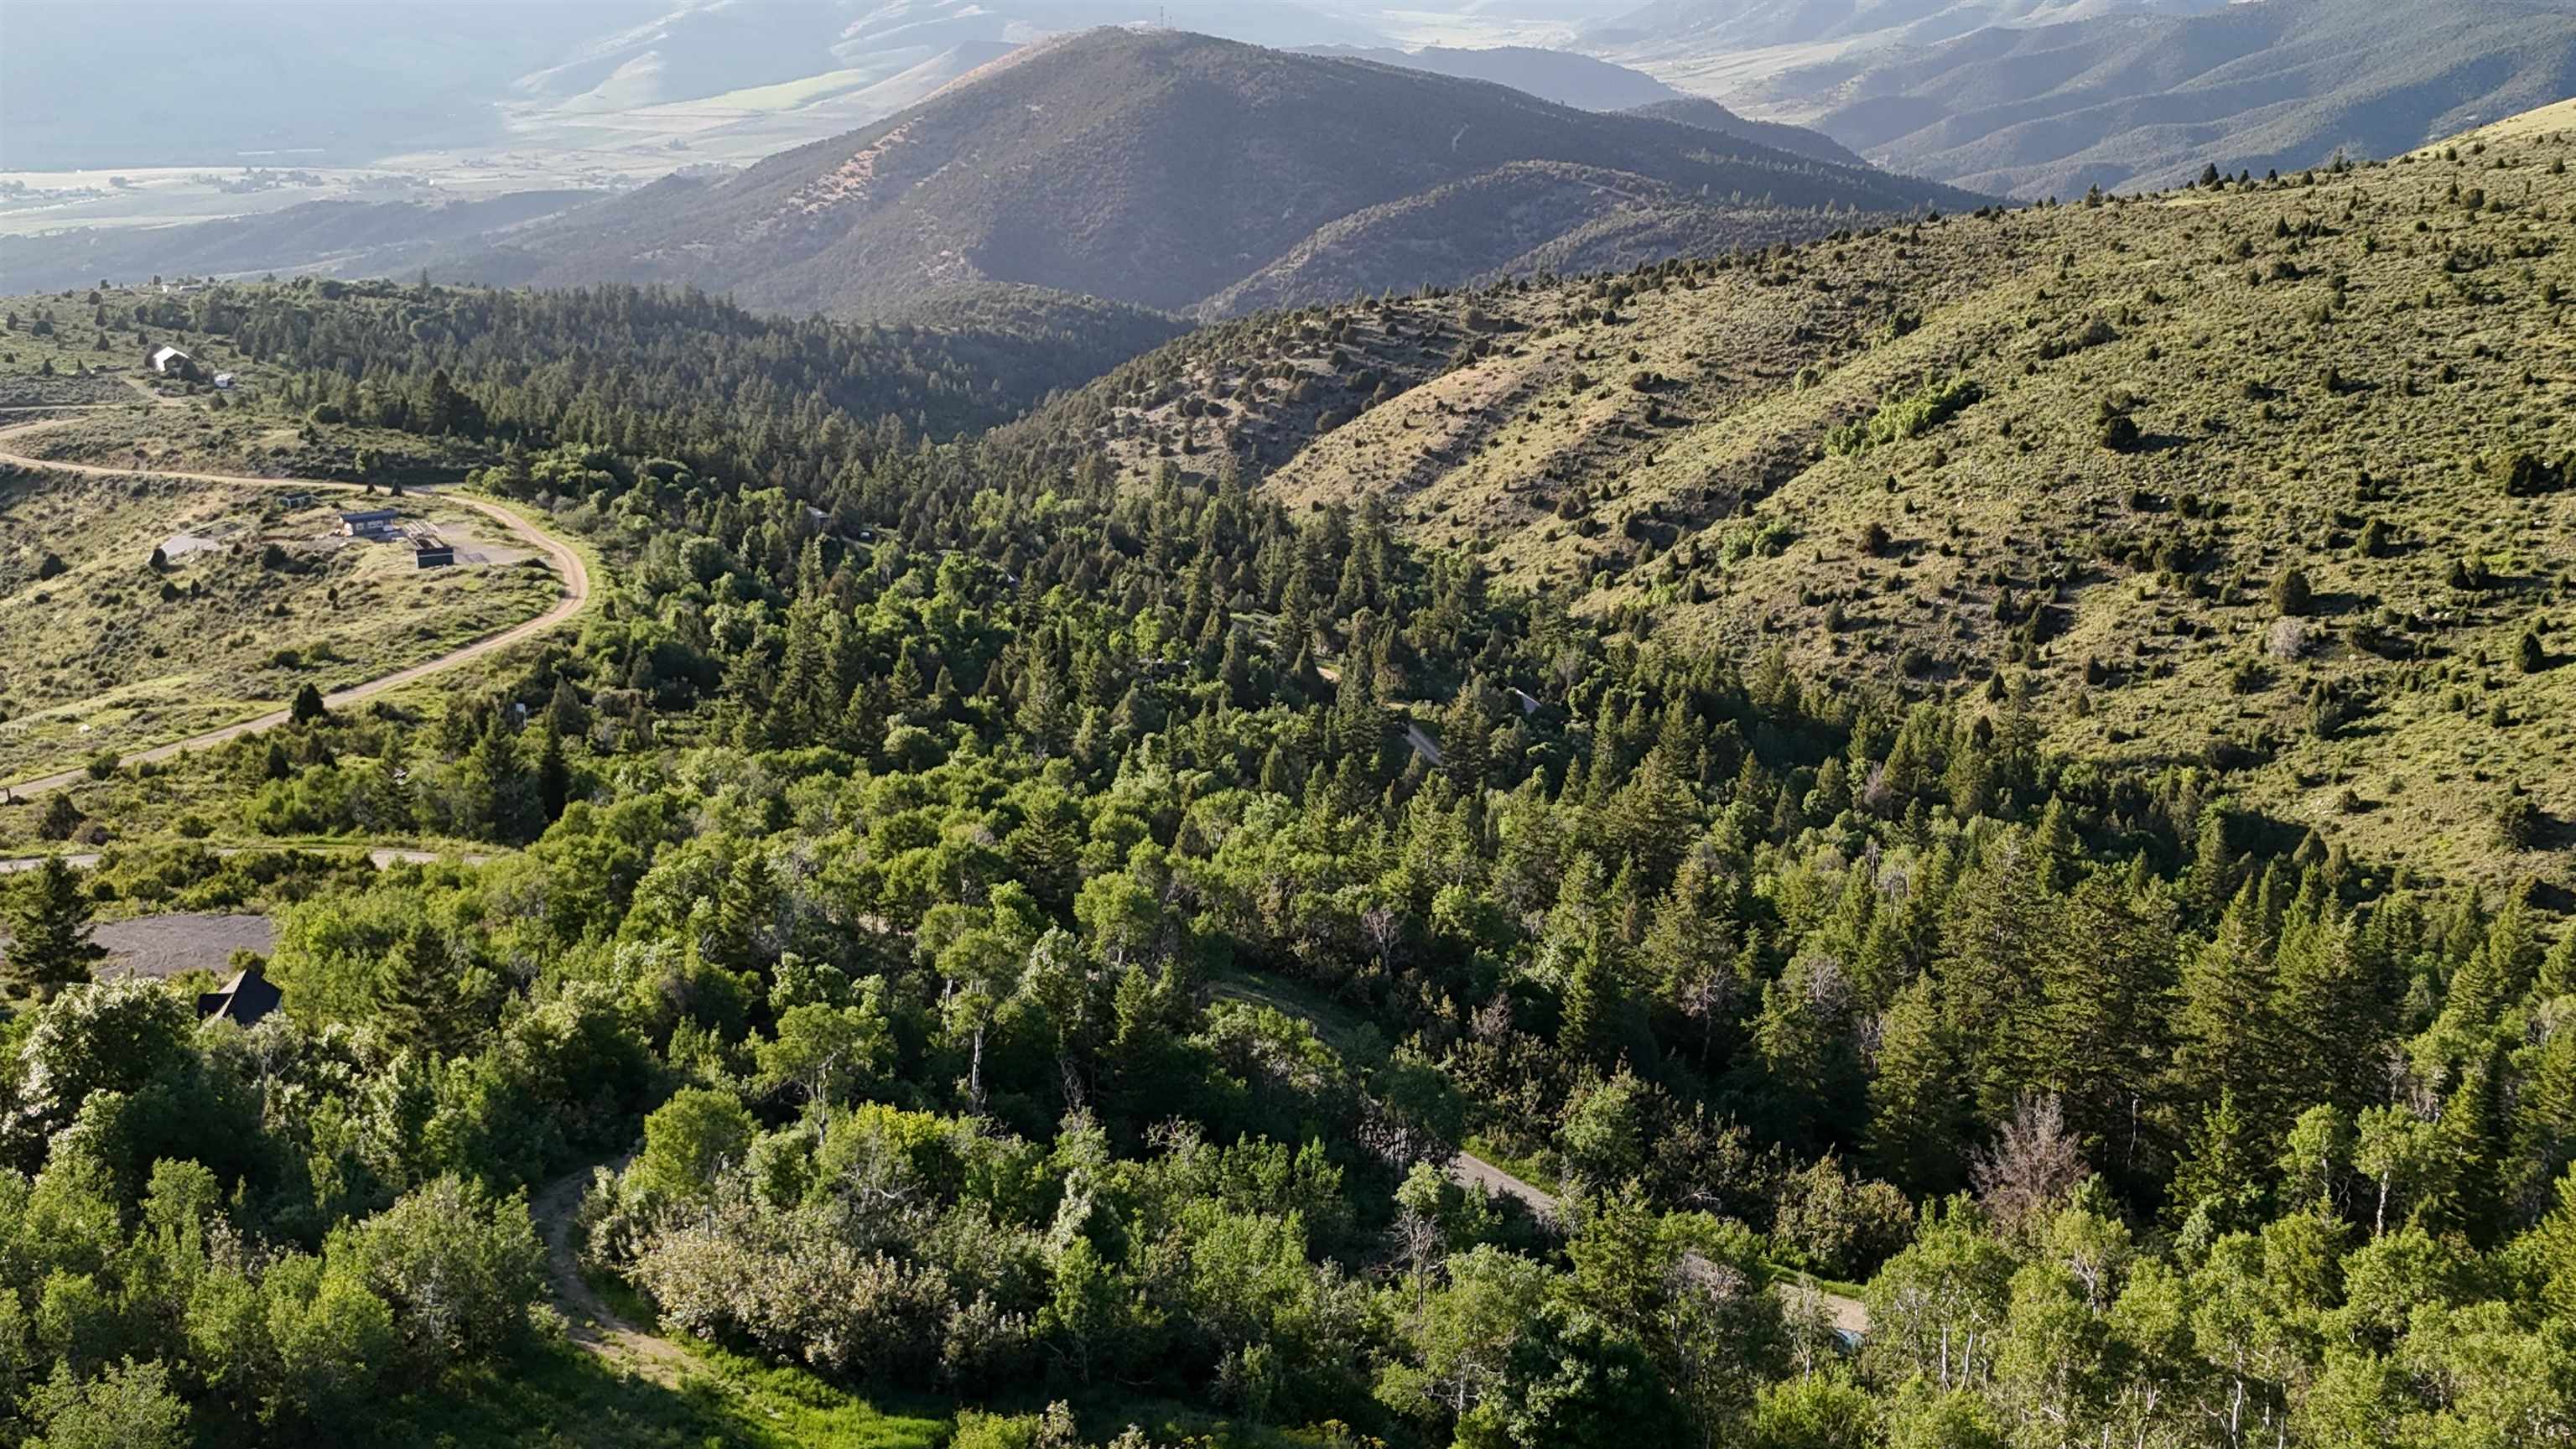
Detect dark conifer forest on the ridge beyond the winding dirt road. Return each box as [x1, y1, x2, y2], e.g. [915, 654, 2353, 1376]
[198, 281, 1180, 461]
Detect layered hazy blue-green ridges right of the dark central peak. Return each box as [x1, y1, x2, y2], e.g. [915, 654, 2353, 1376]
[1581, 0, 2576, 199]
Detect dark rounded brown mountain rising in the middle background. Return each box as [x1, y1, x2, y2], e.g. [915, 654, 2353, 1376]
[443, 31, 1973, 314]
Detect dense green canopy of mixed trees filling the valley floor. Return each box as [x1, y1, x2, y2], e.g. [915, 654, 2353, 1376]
[0, 251, 2576, 1449]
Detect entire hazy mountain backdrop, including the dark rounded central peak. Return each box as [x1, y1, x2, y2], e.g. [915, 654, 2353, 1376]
[0, 0, 2576, 289]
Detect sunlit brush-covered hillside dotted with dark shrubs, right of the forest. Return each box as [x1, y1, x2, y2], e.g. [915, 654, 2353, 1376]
[1026, 127, 2576, 885]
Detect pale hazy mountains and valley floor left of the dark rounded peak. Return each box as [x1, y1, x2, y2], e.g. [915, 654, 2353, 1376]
[0, 0, 1384, 170]
